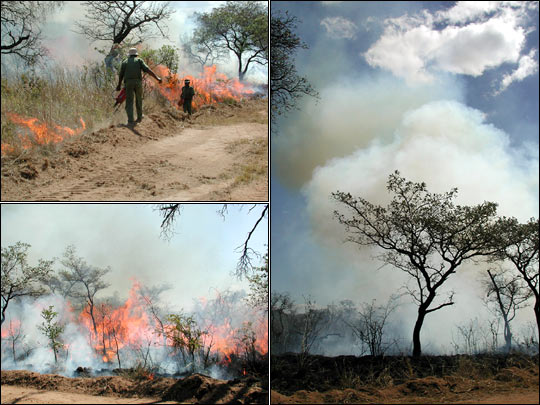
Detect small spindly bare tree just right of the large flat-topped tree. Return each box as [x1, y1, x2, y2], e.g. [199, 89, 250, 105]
[484, 270, 532, 353]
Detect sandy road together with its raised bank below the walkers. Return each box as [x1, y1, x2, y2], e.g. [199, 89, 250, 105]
[2, 100, 268, 201]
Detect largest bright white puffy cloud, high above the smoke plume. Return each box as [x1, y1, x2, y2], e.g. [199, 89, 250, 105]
[364, 2, 530, 83]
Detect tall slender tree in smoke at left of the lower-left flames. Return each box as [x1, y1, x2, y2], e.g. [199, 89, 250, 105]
[59, 245, 111, 348]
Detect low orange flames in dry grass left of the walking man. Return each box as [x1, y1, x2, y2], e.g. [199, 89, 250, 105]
[2, 112, 86, 154]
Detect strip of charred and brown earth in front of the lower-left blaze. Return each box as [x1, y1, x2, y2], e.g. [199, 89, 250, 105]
[1, 370, 268, 404]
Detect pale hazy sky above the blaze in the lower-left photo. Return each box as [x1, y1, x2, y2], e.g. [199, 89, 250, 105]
[2, 204, 268, 310]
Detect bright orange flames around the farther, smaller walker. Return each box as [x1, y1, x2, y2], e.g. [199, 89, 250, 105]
[148, 65, 254, 108]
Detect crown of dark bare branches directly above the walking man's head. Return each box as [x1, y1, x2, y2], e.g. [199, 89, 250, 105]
[76, 1, 174, 44]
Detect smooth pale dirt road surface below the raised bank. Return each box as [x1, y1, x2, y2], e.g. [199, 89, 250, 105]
[37, 124, 268, 201]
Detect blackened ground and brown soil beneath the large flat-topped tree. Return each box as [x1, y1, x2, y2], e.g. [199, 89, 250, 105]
[270, 354, 538, 403]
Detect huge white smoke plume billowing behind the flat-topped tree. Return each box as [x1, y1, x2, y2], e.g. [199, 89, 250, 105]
[272, 52, 539, 354]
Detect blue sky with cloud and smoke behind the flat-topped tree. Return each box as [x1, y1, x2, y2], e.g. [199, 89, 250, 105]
[271, 2, 539, 350]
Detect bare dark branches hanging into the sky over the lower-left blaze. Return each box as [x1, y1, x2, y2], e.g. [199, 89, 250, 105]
[157, 204, 268, 278]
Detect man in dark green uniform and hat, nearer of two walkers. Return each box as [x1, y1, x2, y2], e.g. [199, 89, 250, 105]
[116, 48, 162, 125]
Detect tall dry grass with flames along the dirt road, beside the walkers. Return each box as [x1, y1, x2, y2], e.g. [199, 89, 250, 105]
[1, 65, 268, 157]
